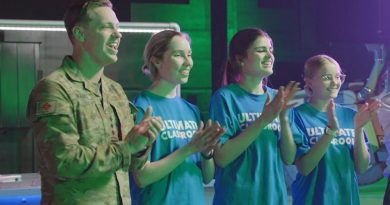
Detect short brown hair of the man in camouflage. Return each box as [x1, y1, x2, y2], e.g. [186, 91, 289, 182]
[64, 0, 112, 42]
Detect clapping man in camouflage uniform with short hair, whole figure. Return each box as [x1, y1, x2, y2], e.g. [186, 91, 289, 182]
[27, 0, 162, 205]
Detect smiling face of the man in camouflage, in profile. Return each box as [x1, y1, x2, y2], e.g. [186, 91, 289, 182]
[83, 7, 122, 66]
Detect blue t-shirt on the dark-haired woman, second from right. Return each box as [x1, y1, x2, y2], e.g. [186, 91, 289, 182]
[210, 84, 287, 205]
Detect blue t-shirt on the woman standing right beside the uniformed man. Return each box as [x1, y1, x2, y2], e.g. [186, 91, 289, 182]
[130, 91, 205, 205]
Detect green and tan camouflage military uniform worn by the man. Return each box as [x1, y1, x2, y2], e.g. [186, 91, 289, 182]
[27, 56, 146, 205]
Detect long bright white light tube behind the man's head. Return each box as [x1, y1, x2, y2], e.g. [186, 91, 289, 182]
[0, 19, 180, 33]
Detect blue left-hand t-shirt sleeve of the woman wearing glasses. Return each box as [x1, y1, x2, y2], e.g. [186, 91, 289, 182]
[289, 109, 310, 160]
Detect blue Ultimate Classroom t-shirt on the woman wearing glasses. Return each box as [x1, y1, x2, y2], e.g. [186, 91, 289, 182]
[291, 103, 359, 205]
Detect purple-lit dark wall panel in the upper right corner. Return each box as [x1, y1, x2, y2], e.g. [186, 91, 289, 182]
[317, 0, 390, 43]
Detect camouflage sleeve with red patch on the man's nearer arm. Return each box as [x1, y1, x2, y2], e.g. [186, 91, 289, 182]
[27, 81, 130, 178]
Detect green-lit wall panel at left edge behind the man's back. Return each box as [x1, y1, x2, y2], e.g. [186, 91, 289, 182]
[0, 43, 39, 128]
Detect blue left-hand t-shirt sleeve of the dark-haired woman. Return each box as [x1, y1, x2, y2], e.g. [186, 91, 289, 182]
[209, 92, 238, 144]
